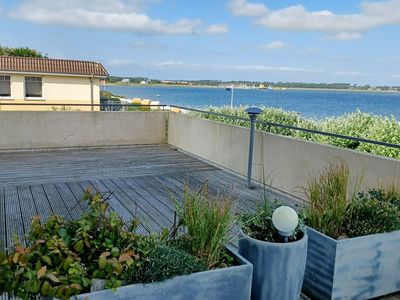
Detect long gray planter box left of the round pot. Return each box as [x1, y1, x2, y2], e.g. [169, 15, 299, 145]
[77, 248, 253, 300]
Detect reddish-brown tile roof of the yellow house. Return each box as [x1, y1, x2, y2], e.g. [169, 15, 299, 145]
[0, 56, 108, 77]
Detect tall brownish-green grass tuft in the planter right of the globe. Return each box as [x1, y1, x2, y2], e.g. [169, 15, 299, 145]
[305, 161, 351, 238]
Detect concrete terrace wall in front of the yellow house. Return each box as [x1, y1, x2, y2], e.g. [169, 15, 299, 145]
[0, 111, 166, 151]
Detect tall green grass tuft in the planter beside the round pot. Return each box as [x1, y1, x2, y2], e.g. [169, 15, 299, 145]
[174, 183, 234, 268]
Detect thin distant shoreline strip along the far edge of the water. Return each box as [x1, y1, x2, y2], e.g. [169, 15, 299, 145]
[103, 83, 400, 93]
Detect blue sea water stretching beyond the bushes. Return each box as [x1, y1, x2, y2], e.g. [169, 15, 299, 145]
[106, 85, 400, 120]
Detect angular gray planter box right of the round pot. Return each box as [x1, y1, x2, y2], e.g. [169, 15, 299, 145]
[303, 228, 400, 299]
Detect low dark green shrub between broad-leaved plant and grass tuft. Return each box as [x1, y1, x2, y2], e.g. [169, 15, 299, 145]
[129, 245, 207, 283]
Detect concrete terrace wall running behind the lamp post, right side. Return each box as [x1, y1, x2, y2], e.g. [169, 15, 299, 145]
[168, 113, 400, 198]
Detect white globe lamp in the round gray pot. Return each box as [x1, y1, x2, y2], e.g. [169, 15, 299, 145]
[272, 206, 299, 236]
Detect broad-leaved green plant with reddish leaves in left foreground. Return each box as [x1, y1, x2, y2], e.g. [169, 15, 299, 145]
[0, 191, 154, 299]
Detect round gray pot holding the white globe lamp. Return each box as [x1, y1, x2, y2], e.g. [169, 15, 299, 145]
[239, 230, 307, 300]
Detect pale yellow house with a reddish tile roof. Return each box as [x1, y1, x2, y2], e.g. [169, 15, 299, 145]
[0, 56, 108, 110]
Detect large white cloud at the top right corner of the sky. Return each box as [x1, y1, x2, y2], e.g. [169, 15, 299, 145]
[231, 0, 400, 40]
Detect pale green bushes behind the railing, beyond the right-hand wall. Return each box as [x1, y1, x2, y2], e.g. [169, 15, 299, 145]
[192, 106, 400, 158]
